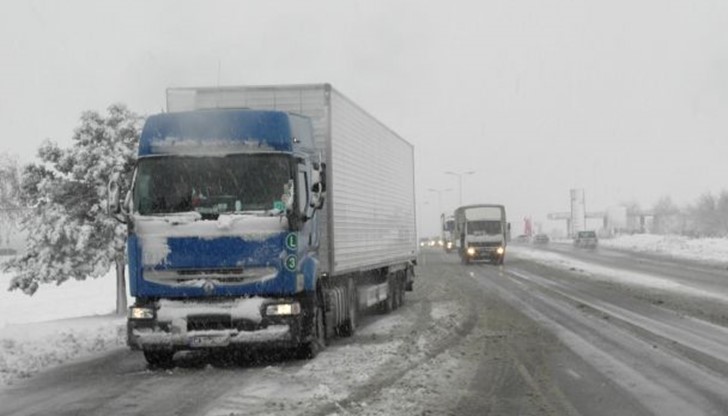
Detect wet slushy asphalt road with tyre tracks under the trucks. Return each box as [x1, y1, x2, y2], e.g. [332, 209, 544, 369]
[0, 244, 728, 415]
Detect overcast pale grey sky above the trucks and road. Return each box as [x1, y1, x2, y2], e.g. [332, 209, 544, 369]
[0, 0, 728, 234]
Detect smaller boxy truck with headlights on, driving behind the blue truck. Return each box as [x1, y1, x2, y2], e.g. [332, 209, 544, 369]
[453, 204, 510, 264]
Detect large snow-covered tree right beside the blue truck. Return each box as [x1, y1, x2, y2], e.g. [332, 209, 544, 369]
[5, 104, 141, 312]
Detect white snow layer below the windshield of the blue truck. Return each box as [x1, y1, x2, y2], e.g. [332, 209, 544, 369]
[133, 212, 288, 266]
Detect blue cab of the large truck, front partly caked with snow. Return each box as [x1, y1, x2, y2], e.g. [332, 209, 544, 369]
[121, 109, 325, 366]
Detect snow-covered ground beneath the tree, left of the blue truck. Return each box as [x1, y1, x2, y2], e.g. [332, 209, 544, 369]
[0, 270, 126, 388]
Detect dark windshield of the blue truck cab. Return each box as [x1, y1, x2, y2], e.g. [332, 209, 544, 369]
[134, 154, 293, 216]
